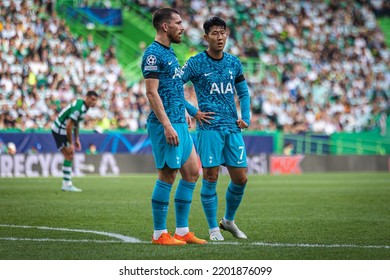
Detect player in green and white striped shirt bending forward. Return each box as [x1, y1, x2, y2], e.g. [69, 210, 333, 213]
[51, 91, 98, 192]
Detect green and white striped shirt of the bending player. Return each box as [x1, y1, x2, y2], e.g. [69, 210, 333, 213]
[51, 99, 88, 135]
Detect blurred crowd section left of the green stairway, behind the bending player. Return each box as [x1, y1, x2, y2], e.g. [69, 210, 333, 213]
[0, 0, 150, 131]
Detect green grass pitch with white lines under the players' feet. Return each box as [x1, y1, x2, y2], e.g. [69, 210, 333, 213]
[0, 173, 390, 260]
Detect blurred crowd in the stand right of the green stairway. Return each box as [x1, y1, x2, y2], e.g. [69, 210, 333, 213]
[139, 0, 390, 134]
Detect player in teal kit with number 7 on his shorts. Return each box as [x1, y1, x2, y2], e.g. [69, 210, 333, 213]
[182, 17, 250, 241]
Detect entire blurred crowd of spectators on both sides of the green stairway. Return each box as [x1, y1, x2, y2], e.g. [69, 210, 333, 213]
[0, 0, 390, 134]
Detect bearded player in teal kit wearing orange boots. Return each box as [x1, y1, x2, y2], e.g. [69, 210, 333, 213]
[141, 8, 210, 245]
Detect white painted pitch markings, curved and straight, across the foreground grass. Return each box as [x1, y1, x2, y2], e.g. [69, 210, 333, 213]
[0, 224, 390, 249]
